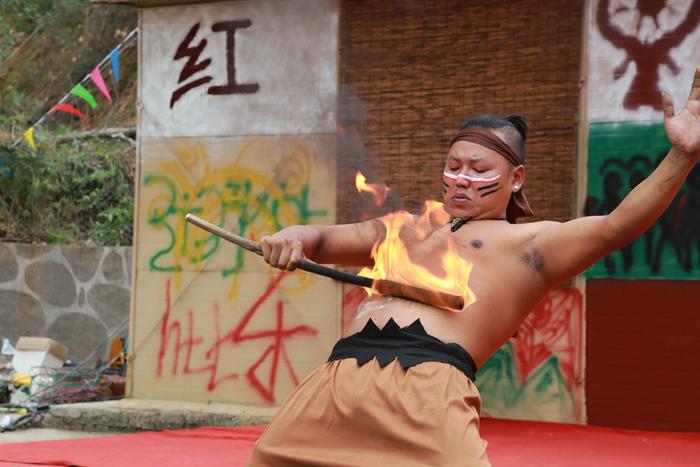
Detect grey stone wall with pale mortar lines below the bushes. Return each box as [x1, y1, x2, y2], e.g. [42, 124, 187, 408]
[0, 243, 131, 360]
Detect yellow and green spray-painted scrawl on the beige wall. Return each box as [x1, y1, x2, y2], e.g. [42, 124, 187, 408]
[143, 139, 326, 298]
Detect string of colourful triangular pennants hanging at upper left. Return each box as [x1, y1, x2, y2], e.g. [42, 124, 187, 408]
[15, 28, 138, 150]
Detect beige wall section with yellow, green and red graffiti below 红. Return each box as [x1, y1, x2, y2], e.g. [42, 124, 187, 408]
[135, 136, 339, 404]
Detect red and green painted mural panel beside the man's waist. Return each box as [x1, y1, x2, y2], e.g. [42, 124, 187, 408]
[476, 287, 583, 422]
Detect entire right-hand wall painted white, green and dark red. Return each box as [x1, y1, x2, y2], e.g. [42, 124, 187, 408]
[585, 0, 700, 431]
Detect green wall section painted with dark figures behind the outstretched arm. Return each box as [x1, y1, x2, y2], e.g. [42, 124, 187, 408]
[584, 122, 700, 279]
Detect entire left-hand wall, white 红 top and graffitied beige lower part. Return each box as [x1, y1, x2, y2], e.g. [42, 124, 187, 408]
[130, 0, 341, 405]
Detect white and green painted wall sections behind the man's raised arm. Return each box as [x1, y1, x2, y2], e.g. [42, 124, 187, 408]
[585, 0, 700, 279]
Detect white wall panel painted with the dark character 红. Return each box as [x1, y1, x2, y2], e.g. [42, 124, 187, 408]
[139, 0, 338, 138]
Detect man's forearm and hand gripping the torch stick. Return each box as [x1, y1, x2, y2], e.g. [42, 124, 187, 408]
[260, 219, 384, 271]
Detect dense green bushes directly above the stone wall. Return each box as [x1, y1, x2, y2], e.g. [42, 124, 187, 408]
[0, 138, 134, 245]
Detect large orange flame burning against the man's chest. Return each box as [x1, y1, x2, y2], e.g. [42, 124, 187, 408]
[360, 201, 476, 308]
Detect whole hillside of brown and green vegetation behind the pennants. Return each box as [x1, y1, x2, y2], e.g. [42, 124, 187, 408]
[0, 0, 137, 245]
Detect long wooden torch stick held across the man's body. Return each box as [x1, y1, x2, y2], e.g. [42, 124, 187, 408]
[185, 214, 464, 311]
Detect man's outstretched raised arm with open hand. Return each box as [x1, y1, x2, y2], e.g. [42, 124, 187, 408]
[528, 67, 700, 285]
